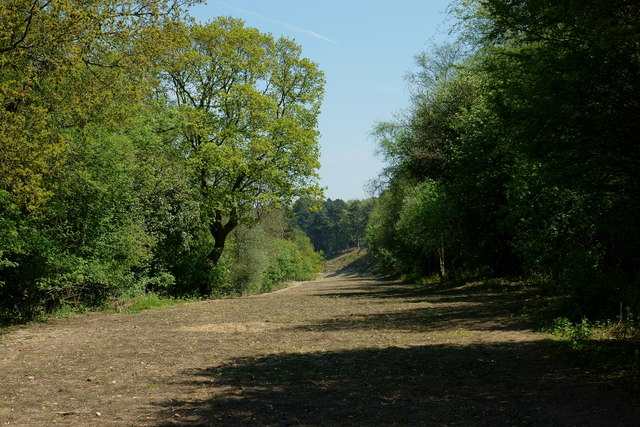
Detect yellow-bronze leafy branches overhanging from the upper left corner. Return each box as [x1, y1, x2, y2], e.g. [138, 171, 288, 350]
[0, 0, 191, 211]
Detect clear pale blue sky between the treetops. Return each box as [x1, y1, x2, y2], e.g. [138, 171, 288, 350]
[191, 0, 452, 200]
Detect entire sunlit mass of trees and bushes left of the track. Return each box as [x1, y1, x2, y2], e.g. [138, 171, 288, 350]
[0, 5, 324, 323]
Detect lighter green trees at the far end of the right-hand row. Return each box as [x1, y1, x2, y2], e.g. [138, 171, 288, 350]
[369, 50, 515, 276]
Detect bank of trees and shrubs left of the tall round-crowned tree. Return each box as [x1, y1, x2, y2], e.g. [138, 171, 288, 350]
[0, 0, 198, 321]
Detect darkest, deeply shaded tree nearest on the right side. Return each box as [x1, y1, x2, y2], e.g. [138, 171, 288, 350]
[465, 0, 640, 317]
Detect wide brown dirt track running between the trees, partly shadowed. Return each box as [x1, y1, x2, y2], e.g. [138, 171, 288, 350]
[0, 275, 640, 426]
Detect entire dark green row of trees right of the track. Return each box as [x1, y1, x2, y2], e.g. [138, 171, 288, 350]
[368, 0, 640, 318]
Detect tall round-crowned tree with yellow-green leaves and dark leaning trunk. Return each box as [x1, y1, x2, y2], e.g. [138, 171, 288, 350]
[166, 18, 324, 294]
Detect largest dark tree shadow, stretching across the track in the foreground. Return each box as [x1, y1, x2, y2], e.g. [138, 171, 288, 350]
[152, 341, 640, 426]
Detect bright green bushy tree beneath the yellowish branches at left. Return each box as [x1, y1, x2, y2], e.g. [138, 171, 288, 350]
[0, 122, 170, 318]
